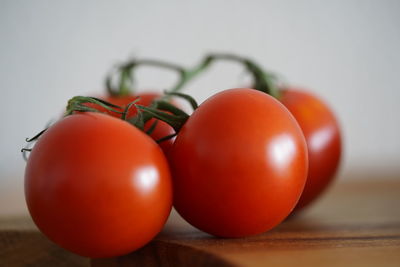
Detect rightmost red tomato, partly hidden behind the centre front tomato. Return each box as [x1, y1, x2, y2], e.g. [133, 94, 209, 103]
[280, 88, 341, 210]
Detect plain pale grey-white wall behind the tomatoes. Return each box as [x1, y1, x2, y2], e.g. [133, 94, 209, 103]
[0, 0, 400, 214]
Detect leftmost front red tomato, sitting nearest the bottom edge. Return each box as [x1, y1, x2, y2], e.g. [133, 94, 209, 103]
[25, 112, 172, 258]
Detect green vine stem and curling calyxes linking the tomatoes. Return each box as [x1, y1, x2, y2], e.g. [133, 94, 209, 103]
[22, 53, 280, 160]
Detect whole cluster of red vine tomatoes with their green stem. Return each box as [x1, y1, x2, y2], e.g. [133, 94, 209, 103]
[25, 52, 341, 258]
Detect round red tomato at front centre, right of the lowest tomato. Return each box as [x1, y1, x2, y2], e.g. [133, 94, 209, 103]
[169, 89, 308, 237]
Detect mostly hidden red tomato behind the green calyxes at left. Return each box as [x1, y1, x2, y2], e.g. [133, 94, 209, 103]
[87, 93, 175, 154]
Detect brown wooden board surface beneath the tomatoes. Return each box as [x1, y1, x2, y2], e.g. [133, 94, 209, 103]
[0, 177, 400, 267]
